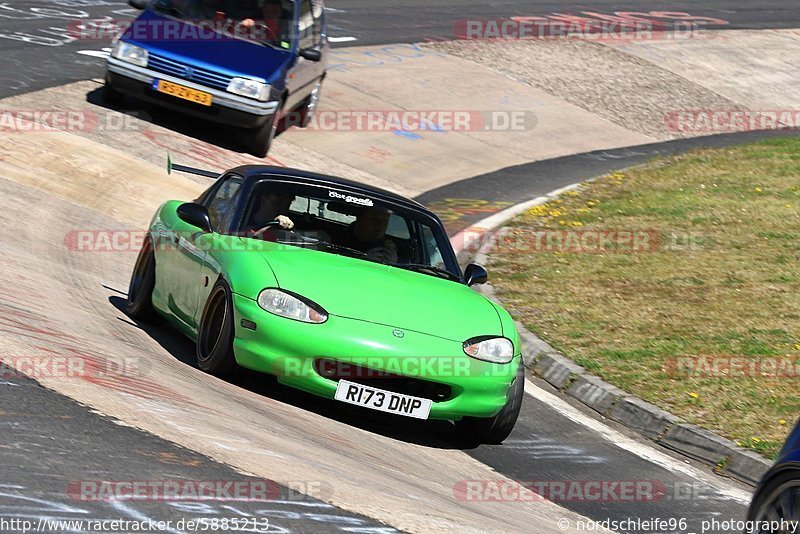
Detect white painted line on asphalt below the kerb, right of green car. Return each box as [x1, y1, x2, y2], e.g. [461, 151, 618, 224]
[525, 379, 752, 506]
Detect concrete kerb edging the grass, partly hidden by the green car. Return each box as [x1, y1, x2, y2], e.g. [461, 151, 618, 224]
[466, 186, 772, 486]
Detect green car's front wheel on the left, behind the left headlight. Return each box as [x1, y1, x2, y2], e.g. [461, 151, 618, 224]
[197, 280, 239, 376]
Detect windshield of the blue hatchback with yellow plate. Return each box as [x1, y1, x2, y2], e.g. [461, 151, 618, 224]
[151, 0, 294, 49]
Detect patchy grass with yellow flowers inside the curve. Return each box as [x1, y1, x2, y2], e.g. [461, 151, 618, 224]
[490, 139, 800, 457]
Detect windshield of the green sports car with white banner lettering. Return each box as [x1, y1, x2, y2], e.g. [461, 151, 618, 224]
[241, 180, 461, 280]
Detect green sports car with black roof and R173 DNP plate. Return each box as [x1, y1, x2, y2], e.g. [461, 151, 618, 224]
[127, 166, 524, 443]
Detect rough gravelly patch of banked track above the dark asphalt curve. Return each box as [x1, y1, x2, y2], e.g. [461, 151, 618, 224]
[425, 40, 744, 140]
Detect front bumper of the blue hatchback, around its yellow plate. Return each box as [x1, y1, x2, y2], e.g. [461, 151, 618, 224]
[106, 57, 278, 128]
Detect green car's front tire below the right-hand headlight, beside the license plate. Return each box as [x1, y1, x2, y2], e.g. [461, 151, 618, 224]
[456, 362, 525, 445]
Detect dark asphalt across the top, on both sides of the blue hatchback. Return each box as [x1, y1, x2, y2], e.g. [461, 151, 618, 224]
[0, 0, 800, 98]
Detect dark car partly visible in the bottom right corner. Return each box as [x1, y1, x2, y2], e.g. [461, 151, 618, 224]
[747, 421, 800, 534]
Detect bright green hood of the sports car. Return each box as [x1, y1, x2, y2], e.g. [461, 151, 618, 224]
[263, 248, 503, 342]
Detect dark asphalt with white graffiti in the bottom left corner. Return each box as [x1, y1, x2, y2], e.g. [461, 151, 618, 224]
[0, 377, 396, 534]
